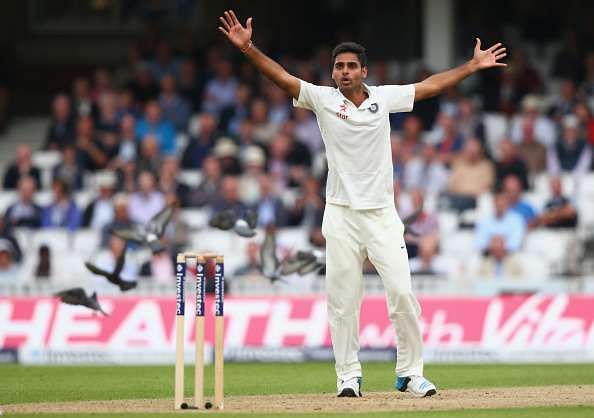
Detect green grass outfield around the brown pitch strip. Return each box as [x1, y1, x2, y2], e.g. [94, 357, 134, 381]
[0, 363, 594, 418]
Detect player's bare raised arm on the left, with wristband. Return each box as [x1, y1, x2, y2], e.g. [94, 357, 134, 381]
[219, 10, 301, 99]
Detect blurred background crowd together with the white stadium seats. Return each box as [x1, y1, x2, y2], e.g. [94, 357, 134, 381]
[0, 2, 594, 294]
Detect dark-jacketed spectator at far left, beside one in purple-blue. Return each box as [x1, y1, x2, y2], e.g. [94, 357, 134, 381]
[4, 177, 43, 229]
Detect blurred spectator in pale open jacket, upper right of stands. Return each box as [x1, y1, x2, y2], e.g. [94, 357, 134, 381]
[511, 95, 555, 147]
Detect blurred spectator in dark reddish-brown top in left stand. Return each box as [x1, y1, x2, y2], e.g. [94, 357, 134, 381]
[76, 116, 108, 171]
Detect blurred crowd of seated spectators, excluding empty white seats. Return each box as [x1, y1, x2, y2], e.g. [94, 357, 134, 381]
[0, 33, 594, 284]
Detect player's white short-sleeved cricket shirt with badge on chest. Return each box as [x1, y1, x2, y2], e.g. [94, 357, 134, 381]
[293, 80, 415, 210]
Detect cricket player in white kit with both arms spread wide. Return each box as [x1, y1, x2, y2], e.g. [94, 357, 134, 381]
[219, 10, 506, 397]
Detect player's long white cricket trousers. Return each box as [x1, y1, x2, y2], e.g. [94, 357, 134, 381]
[322, 203, 423, 380]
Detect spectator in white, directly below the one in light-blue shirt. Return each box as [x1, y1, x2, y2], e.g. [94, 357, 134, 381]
[477, 235, 524, 278]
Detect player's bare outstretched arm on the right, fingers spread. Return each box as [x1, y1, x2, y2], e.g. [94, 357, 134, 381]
[415, 38, 507, 101]
